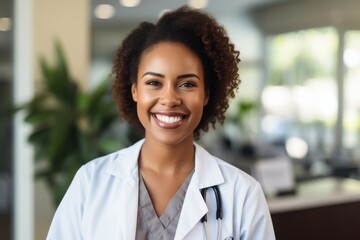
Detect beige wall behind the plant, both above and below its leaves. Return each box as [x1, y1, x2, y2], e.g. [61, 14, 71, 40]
[33, 0, 90, 239]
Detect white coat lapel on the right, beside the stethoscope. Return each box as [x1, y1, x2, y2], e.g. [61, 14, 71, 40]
[175, 144, 224, 240]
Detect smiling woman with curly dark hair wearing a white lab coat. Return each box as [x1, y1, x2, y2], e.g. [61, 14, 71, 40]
[48, 7, 275, 240]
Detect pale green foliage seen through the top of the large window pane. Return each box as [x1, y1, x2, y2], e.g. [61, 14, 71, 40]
[268, 27, 338, 86]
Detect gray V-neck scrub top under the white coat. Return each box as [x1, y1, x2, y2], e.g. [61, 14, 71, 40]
[136, 170, 194, 240]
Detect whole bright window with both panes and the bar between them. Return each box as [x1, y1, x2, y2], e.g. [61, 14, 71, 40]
[261, 27, 360, 177]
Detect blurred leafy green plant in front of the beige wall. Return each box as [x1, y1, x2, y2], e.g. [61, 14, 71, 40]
[19, 43, 132, 206]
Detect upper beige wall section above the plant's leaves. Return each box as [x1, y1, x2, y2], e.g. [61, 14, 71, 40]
[33, 0, 90, 87]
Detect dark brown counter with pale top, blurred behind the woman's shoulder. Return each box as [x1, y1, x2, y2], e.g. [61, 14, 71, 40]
[268, 178, 360, 240]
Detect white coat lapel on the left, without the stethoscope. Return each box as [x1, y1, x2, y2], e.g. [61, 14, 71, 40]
[109, 141, 143, 239]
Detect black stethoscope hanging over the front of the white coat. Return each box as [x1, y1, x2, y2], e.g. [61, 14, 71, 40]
[200, 186, 223, 240]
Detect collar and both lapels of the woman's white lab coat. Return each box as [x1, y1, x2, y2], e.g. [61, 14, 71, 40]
[109, 140, 224, 240]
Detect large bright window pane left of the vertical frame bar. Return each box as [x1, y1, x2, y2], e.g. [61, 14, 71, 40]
[261, 27, 338, 176]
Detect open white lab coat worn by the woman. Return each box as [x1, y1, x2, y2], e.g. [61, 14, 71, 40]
[47, 140, 275, 240]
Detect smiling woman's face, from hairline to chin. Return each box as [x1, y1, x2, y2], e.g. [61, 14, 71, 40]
[131, 42, 208, 144]
